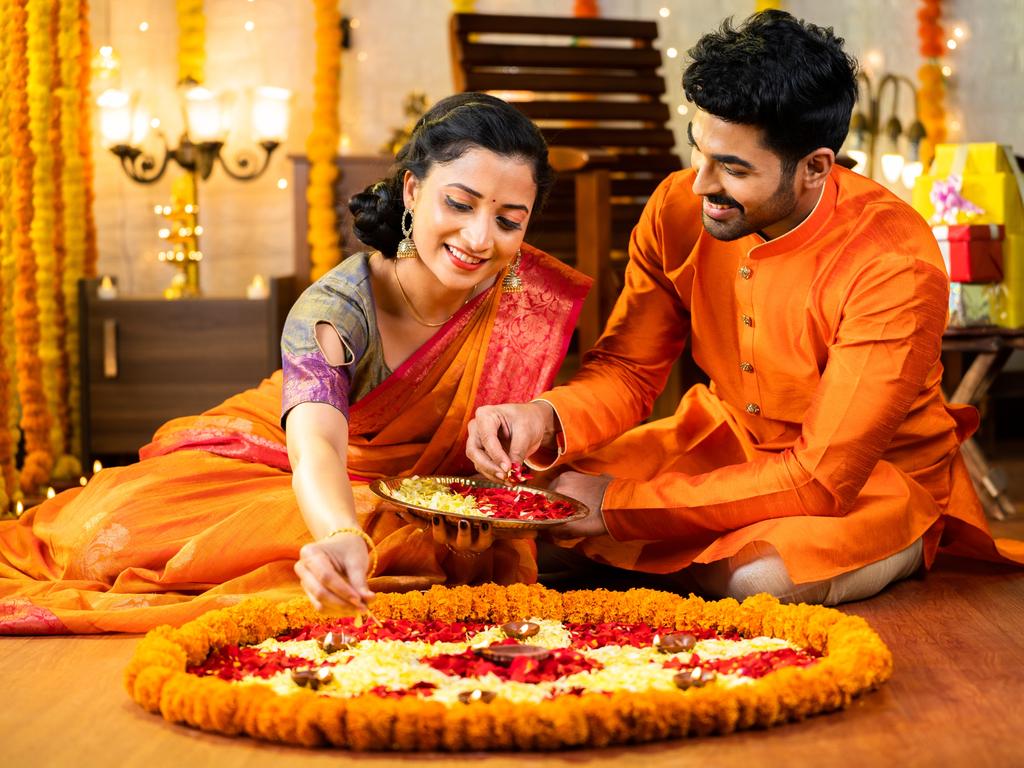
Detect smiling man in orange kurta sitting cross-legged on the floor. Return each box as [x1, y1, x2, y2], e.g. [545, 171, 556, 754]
[467, 11, 1019, 604]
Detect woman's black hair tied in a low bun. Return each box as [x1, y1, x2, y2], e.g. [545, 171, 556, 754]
[348, 91, 554, 256]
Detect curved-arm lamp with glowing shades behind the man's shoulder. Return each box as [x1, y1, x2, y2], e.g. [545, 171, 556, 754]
[845, 72, 926, 186]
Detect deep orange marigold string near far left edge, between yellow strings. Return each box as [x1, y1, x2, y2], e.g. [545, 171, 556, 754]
[6, 0, 53, 493]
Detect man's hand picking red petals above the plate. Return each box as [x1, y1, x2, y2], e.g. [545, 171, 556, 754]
[466, 401, 556, 482]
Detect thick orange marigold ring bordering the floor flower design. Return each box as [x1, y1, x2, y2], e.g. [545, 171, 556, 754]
[125, 585, 893, 752]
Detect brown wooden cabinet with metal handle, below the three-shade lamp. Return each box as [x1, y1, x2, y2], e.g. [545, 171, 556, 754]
[79, 278, 295, 466]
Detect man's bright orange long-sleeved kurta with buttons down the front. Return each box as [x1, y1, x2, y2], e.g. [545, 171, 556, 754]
[543, 167, 1024, 583]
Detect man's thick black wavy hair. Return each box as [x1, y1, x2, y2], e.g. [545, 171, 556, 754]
[683, 10, 857, 173]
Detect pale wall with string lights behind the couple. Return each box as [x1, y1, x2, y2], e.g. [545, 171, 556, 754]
[91, 0, 1024, 295]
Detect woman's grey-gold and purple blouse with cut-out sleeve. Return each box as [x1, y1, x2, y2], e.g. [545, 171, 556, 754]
[281, 253, 391, 424]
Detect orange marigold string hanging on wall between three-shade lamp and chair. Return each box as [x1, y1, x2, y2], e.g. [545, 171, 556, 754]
[306, 0, 341, 281]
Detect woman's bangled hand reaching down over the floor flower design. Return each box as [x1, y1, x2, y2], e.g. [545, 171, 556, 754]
[295, 534, 374, 610]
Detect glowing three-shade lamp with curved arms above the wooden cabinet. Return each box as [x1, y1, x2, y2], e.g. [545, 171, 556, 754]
[98, 80, 291, 184]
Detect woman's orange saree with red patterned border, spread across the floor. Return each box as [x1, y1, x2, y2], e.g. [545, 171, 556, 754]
[0, 246, 590, 634]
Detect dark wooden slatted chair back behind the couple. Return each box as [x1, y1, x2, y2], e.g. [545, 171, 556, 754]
[451, 13, 682, 278]
